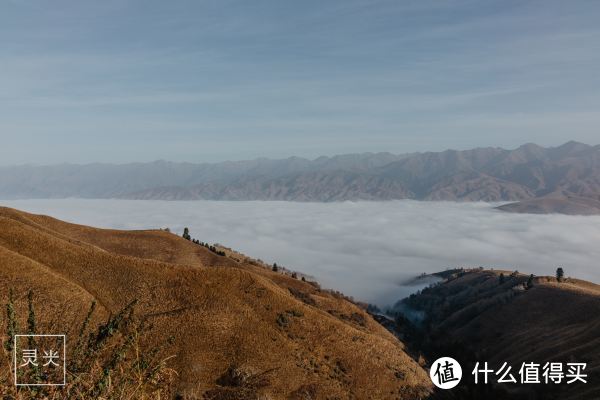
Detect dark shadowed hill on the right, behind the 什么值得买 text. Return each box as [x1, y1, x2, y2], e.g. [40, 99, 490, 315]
[403, 270, 600, 400]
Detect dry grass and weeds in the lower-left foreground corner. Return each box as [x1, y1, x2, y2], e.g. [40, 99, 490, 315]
[0, 291, 176, 400]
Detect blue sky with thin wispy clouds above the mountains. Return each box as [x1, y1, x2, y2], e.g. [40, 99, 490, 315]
[0, 0, 600, 164]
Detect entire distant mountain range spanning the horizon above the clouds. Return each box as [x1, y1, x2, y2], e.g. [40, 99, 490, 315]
[0, 141, 600, 209]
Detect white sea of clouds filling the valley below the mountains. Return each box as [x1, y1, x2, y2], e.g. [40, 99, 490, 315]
[0, 199, 600, 306]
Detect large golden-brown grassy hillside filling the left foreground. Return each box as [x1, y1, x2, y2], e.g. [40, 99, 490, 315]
[0, 208, 430, 399]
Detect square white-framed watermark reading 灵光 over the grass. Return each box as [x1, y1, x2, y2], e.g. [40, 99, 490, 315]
[13, 335, 67, 386]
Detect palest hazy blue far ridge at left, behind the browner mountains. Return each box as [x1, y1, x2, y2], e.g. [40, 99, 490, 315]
[0, 153, 403, 199]
